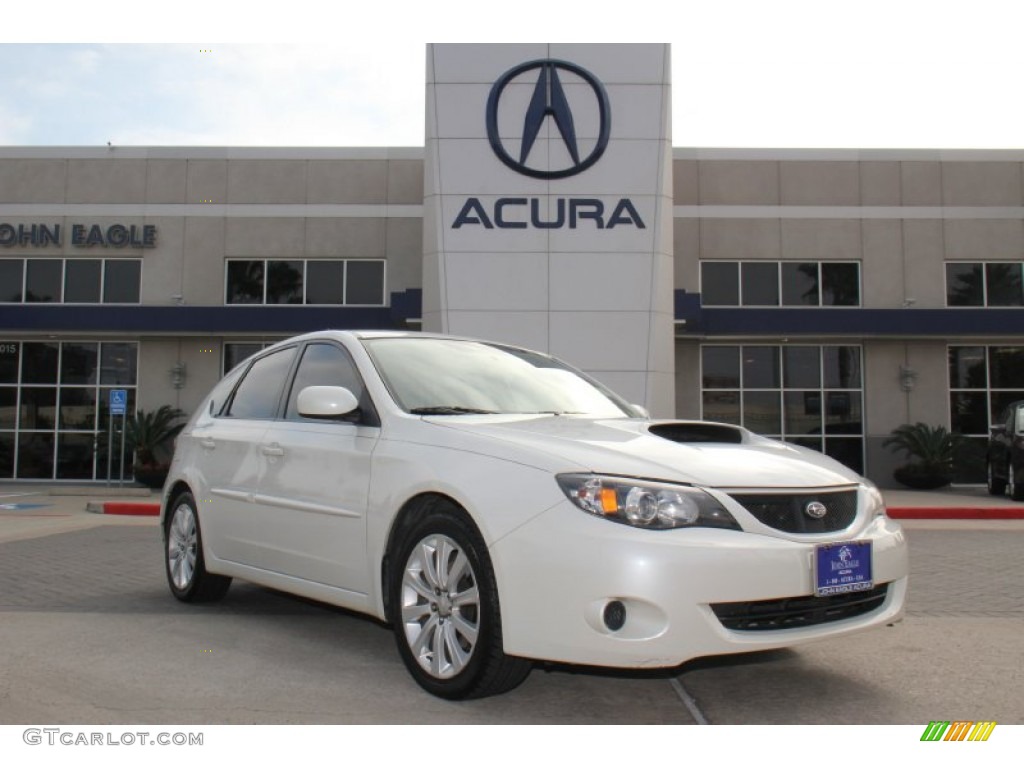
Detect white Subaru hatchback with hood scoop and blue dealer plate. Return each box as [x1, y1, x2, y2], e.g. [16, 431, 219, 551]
[161, 331, 907, 698]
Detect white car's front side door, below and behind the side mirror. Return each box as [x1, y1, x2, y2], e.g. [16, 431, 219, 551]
[251, 340, 380, 594]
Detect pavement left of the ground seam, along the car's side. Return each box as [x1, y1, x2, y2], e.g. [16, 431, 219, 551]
[0, 525, 693, 724]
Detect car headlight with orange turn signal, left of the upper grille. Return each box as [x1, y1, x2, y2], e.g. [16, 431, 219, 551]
[555, 474, 740, 530]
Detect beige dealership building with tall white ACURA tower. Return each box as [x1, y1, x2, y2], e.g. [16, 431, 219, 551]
[0, 44, 1024, 485]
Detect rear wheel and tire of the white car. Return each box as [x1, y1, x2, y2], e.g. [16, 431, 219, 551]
[164, 493, 231, 603]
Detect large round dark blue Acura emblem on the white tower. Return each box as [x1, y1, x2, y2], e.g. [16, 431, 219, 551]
[486, 58, 611, 179]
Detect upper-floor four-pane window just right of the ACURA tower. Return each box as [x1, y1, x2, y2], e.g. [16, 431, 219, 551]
[700, 261, 860, 307]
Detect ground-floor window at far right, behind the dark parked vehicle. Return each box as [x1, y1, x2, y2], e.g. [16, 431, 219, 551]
[949, 346, 1024, 482]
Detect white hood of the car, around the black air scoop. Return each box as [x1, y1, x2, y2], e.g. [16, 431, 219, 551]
[429, 416, 860, 488]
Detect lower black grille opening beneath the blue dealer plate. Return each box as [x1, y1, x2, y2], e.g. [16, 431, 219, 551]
[711, 584, 889, 632]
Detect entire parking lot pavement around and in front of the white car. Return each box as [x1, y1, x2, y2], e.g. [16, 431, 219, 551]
[0, 499, 1024, 724]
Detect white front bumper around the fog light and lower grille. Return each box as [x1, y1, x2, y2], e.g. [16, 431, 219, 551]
[490, 501, 908, 668]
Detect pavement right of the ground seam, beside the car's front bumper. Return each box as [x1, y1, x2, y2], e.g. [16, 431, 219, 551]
[680, 522, 1024, 724]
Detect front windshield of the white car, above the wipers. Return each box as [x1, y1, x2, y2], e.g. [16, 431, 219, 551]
[362, 337, 635, 419]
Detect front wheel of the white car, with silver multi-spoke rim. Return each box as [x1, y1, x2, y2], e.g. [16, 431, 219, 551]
[389, 502, 530, 699]
